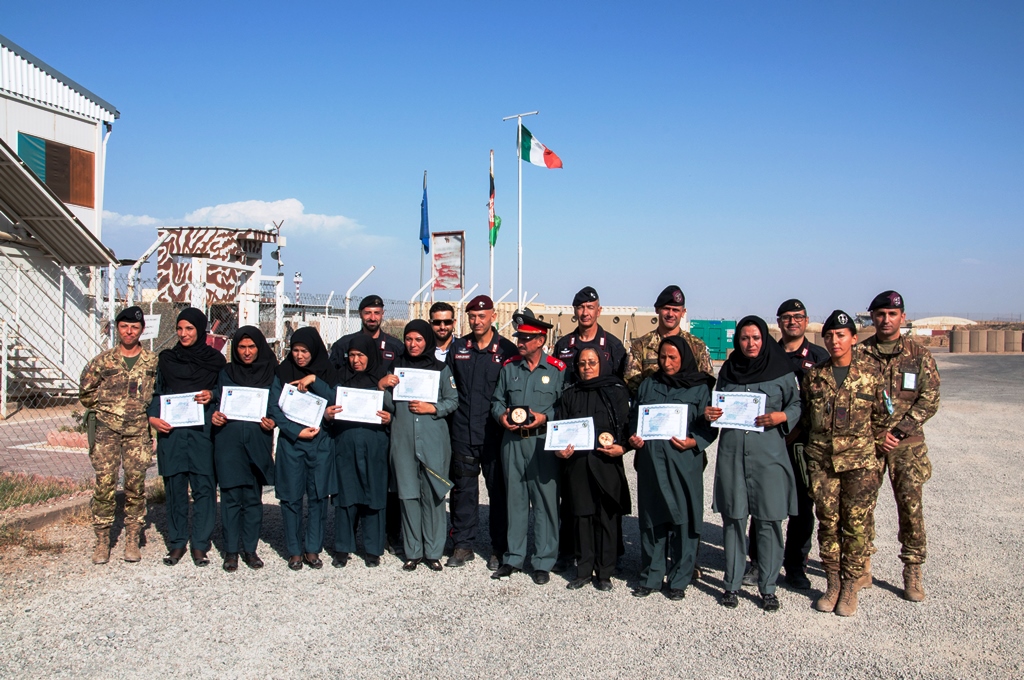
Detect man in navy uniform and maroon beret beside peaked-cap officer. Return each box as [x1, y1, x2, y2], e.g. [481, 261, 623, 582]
[446, 295, 518, 571]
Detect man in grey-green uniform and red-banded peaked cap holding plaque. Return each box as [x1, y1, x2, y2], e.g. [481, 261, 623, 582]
[490, 309, 565, 586]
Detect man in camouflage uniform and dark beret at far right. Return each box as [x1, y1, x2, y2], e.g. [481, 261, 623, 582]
[859, 291, 939, 602]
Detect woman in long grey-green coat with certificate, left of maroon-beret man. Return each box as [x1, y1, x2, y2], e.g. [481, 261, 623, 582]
[380, 318, 459, 571]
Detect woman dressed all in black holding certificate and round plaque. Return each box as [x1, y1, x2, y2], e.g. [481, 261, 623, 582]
[555, 347, 632, 591]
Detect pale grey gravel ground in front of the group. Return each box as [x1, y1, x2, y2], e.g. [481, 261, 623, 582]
[0, 354, 1024, 678]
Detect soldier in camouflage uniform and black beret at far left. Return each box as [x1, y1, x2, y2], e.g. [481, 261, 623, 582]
[79, 307, 157, 564]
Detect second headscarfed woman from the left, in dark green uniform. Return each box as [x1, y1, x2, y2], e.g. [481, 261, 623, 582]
[212, 326, 278, 571]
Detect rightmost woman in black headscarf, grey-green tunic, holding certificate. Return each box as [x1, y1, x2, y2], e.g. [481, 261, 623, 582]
[705, 316, 801, 611]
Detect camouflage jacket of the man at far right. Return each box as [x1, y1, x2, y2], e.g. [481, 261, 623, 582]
[854, 337, 939, 436]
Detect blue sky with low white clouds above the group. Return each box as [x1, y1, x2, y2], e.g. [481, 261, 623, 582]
[0, 0, 1024, 317]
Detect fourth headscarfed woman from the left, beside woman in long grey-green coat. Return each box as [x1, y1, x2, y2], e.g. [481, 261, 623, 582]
[327, 333, 393, 567]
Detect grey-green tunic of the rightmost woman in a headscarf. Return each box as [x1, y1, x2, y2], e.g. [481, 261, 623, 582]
[712, 373, 800, 521]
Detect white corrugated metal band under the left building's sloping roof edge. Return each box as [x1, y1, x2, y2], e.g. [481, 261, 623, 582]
[0, 35, 121, 122]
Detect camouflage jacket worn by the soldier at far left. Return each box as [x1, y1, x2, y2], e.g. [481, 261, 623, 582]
[79, 347, 157, 434]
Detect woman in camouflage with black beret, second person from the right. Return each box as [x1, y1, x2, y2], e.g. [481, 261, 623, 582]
[801, 309, 887, 617]
